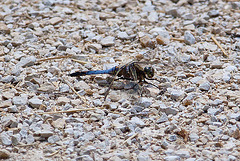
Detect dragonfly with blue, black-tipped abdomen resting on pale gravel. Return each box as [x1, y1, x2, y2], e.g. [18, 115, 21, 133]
[70, 61, 160, 101]
